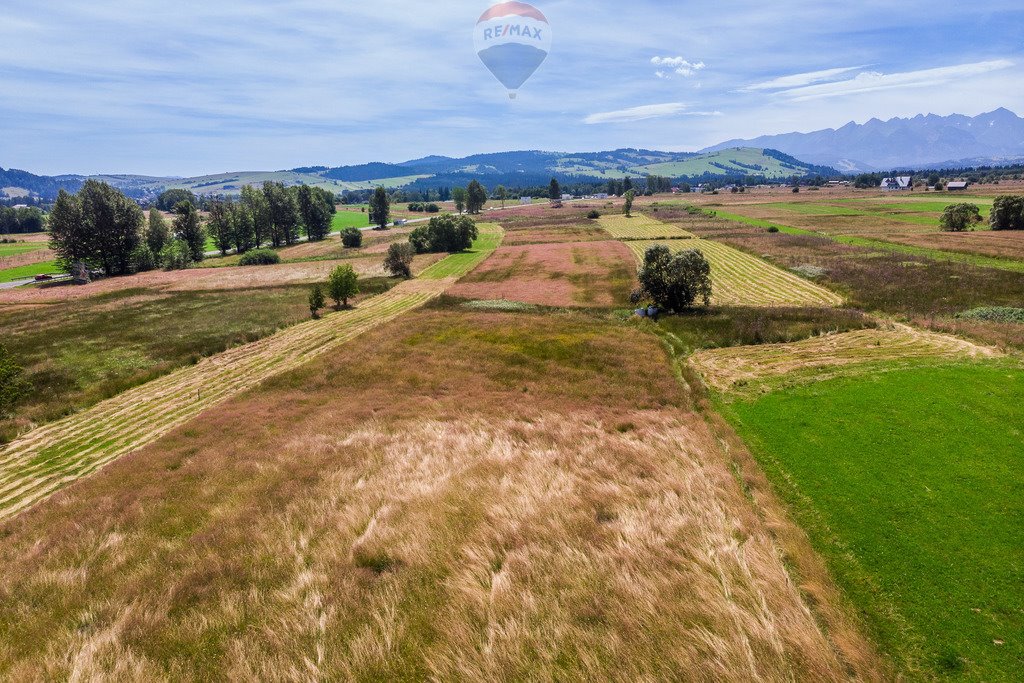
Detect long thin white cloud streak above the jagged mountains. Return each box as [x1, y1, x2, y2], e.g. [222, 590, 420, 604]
[778, 59, 1014, 102]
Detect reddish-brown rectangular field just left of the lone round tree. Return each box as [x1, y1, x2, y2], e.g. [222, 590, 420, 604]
[450, 242, 636, 306]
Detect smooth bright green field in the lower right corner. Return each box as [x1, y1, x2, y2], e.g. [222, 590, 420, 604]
[725, 362, 1024, 681]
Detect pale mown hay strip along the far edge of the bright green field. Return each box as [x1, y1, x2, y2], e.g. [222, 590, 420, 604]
[690, 325, 1000, 391]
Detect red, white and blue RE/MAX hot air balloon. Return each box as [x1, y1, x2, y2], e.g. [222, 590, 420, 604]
[473, 2, 551, 99]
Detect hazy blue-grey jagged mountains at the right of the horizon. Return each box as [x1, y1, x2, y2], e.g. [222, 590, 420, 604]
[705, 109, 1024, 173]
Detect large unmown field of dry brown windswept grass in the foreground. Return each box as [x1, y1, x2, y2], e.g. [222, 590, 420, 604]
[0, 310, 884, 681]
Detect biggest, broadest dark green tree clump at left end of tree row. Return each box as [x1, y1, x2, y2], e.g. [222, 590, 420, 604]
[50, 180, 145, 275]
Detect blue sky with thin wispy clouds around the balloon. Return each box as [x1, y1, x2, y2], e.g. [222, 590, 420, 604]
[0, 0, 1024, 175]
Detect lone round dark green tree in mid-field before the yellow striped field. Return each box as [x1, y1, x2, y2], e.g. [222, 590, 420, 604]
[634, 245, 711, 312]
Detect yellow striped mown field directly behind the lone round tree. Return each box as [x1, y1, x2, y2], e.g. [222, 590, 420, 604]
[627, 240, 843, 307]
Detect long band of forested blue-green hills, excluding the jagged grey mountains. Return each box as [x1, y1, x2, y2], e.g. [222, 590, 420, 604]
[0, 147, 837, 199]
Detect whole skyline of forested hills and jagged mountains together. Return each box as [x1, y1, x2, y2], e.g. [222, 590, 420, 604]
[0, 109, 1024, 200]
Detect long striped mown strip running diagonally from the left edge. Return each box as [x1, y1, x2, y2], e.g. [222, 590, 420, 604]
[0, 224, 502, 521]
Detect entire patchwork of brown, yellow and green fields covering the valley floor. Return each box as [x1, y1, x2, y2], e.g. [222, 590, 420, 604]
[0, 187, 1024, 681]
